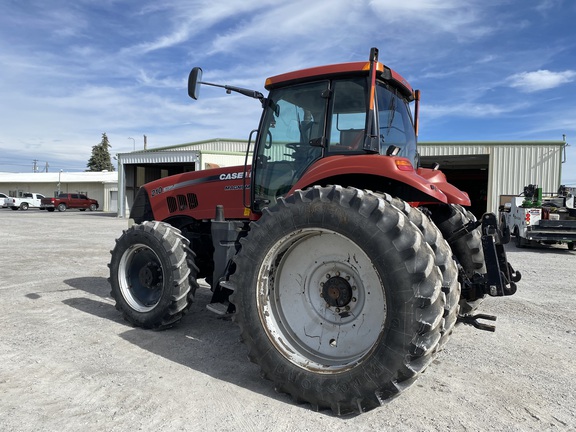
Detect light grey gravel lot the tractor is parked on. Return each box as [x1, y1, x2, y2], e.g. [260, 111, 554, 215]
[0, 209, 576, 432]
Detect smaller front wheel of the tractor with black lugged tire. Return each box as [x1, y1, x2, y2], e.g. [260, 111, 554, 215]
[109, 221, 198, 330]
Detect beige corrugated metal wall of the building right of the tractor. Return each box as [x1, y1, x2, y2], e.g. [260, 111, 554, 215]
[419, 141, 566, 212]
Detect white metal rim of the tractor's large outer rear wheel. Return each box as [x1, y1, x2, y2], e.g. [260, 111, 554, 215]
[257, 228, 386, 373]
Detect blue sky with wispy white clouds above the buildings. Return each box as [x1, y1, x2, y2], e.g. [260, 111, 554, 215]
[0, 0, 576, 185]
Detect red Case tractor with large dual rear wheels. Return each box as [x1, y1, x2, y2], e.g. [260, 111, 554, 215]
[109, 48, 520, 415]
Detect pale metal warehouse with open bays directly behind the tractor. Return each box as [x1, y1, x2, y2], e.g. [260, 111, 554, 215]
[117, 139, 567, 217]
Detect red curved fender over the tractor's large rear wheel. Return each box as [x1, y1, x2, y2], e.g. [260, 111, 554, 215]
[288, 154, 448, 203]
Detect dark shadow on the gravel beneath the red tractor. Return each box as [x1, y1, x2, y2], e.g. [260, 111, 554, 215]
[63, 277, 292, 408]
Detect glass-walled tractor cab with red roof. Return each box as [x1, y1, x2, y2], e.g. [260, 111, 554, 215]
[251, 52, 417, 210]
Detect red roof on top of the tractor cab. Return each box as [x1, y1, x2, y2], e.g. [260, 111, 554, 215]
[265, 62, 414, 100]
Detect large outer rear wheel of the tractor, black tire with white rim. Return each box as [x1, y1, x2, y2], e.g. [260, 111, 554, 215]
[229, 186, 445, 415]
